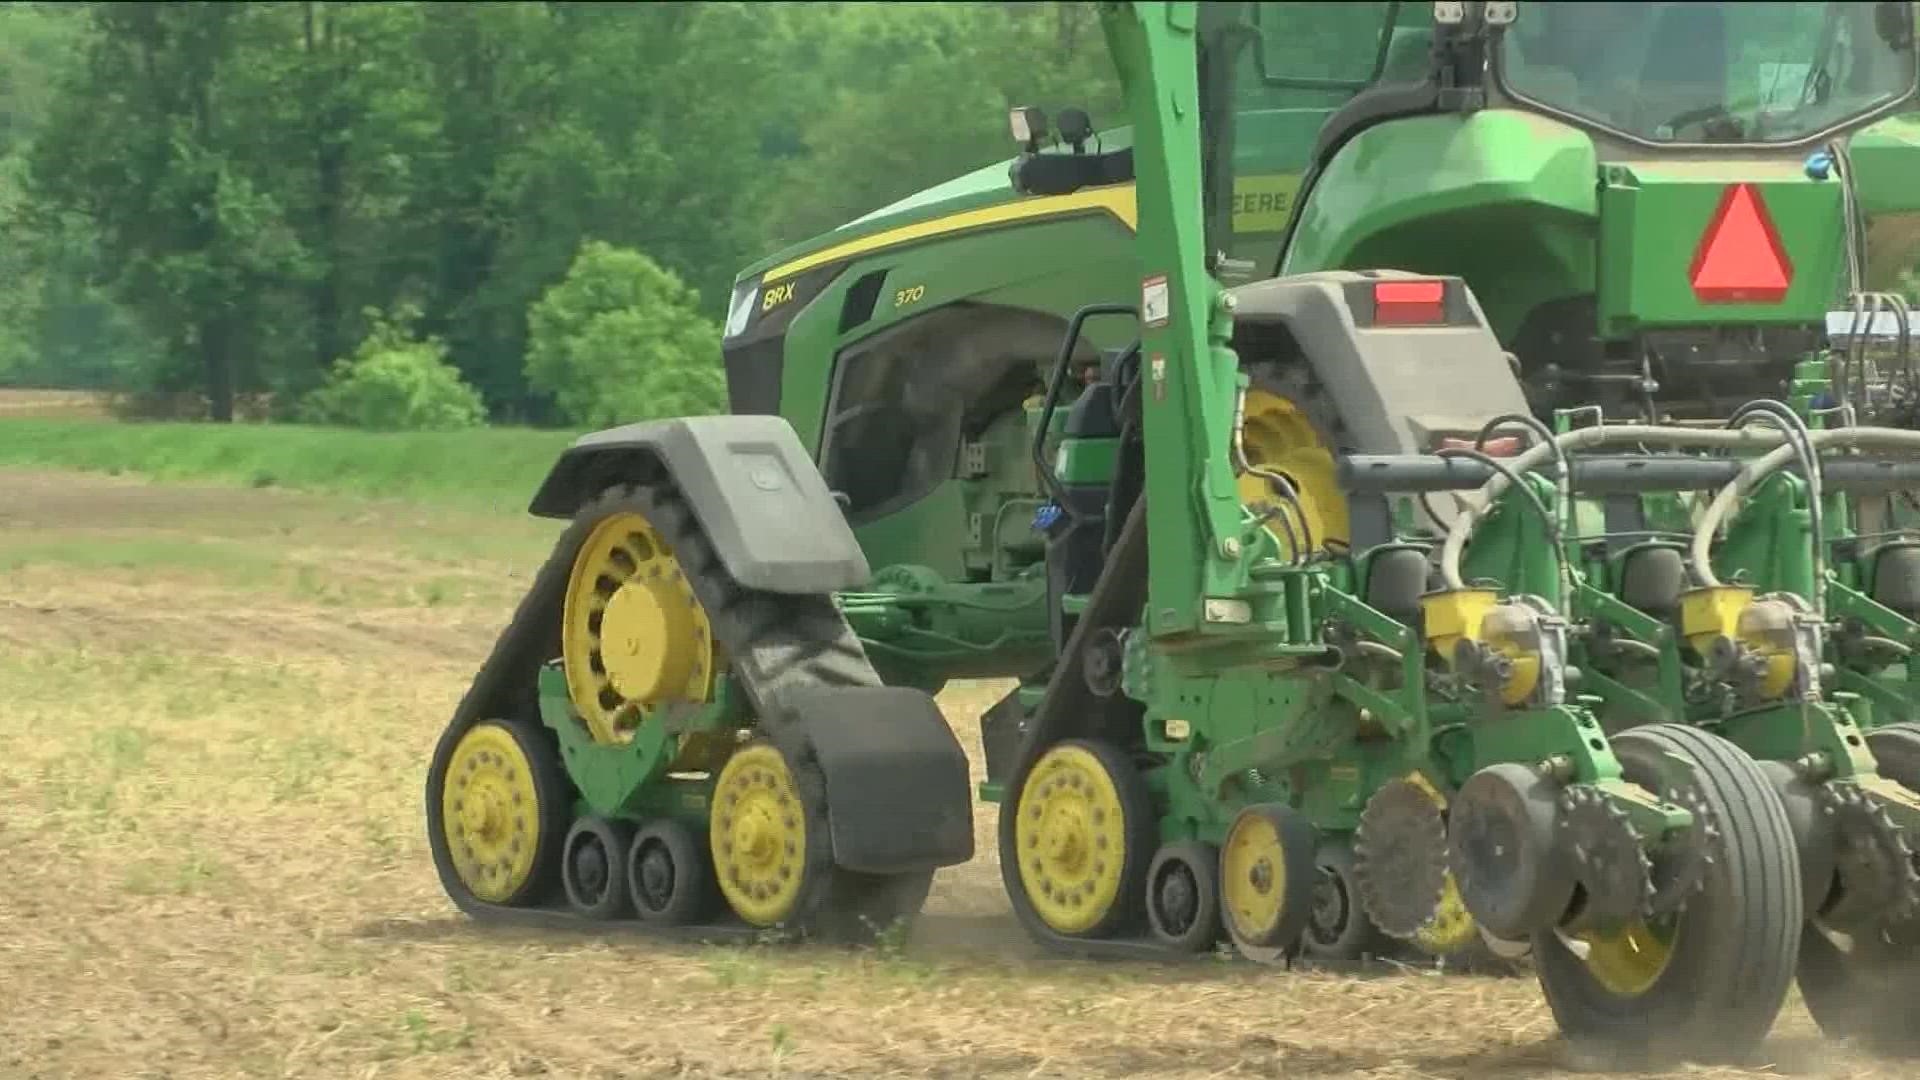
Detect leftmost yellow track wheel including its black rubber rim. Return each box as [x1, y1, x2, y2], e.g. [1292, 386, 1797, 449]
[426, 721, 572, 907]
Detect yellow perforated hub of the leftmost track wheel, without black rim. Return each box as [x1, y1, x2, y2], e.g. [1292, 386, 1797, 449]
[440, 723, 540, 903]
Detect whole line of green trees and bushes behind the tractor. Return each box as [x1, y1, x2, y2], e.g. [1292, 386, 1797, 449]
[0, 0, 1112, 427]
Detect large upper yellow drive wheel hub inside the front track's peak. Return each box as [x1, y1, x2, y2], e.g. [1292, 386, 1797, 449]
[561, 511, 718, 744]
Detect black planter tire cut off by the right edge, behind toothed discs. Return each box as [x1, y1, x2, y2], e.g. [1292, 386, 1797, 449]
[1799, 723, 1920, 1057]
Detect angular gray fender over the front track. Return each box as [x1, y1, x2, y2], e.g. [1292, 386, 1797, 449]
[528, 415, 872, 594]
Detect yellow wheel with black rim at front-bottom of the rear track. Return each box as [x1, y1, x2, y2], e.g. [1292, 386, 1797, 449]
[1014, 740, 1154, 938]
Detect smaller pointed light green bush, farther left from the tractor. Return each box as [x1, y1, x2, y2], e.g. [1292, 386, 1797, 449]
[301, 307, 486, 430]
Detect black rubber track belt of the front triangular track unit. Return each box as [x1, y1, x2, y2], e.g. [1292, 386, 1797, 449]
[428, 480, 881, 930]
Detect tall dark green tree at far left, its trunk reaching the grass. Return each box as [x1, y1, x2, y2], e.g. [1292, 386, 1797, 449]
[27, 4, 305, 421]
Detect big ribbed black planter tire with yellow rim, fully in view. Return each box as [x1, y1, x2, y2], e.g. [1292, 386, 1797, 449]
[1534, 724, 1803, 1067]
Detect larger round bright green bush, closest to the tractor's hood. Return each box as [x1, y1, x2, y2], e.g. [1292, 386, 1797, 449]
[526, 240, 726, 427]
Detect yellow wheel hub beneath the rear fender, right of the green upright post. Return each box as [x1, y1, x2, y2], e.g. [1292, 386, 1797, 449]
[1238, 388, 1348, 555]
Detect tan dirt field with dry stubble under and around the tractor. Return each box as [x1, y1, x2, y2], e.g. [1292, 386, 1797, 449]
[0, 473, 1910, 1080]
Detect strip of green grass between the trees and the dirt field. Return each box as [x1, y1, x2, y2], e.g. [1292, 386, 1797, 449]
[0, 419, 578, 513]
